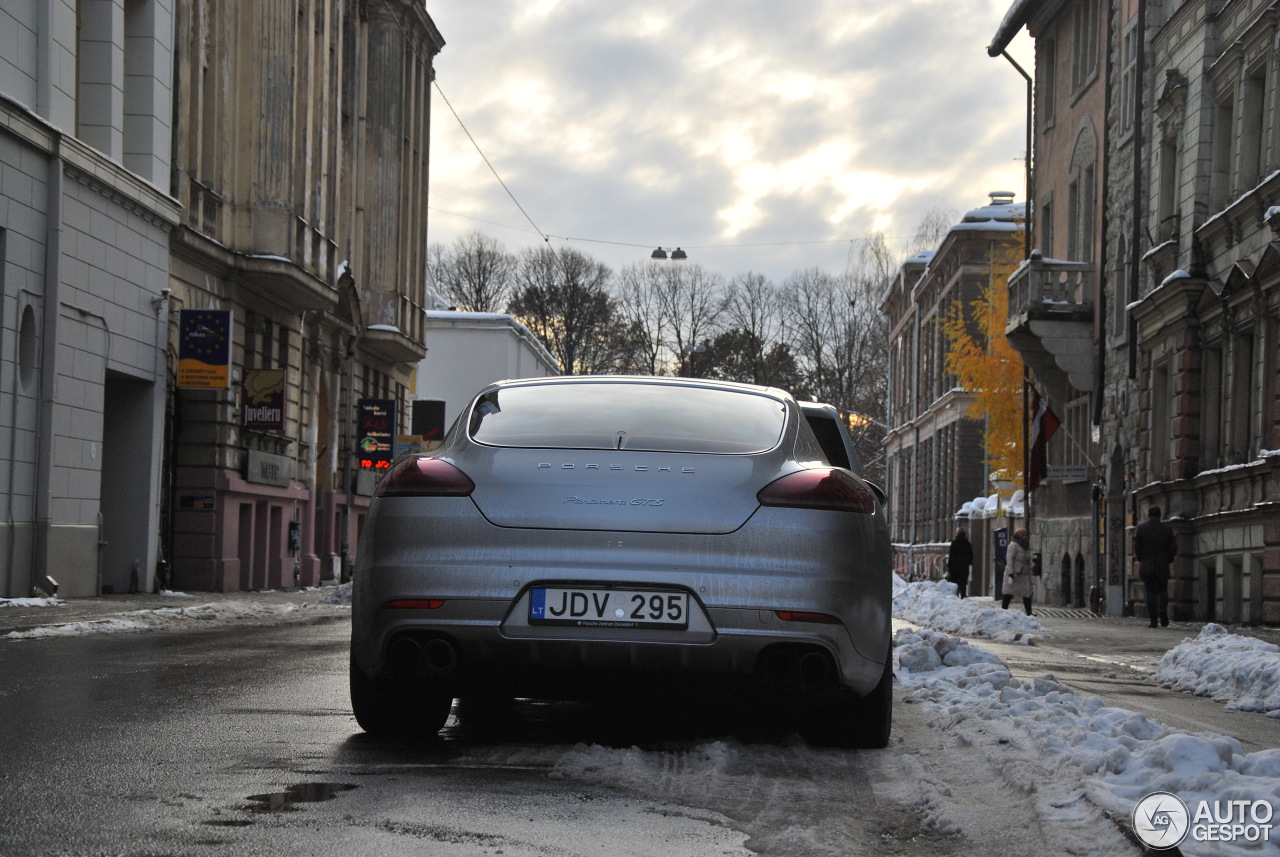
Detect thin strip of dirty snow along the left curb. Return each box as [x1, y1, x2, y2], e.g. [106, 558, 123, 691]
[4, 601, 343, 641]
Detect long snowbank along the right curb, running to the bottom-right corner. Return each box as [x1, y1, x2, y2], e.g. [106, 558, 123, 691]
[893, 629, 1280, 857]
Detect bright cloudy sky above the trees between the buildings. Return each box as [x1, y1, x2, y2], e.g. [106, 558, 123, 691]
[428, 0, 1032, 280]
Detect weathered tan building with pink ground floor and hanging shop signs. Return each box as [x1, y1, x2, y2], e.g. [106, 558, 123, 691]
[164, 0, 444, 591]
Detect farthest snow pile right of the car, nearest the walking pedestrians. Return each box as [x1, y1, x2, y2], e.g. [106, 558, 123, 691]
[893, 574, 1044, 642]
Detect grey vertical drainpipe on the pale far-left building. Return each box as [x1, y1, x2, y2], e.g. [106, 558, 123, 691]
[29, 155, 64, 595]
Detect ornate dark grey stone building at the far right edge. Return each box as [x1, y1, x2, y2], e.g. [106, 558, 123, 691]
[1129, 0, 1280, 623]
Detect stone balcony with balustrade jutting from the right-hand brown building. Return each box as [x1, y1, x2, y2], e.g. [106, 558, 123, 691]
[1005, 251, 1097, 391]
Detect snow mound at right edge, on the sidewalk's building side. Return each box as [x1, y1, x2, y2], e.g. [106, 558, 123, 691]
[1156, 624, 1280, 719]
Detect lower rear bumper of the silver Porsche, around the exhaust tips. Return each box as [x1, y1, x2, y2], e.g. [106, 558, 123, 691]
[352, 600, 887, 698]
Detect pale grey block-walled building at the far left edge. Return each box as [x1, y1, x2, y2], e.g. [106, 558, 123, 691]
[0, 0, 179, 597]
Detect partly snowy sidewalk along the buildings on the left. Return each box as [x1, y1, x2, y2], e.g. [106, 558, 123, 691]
[0, 586, 351, 642]
